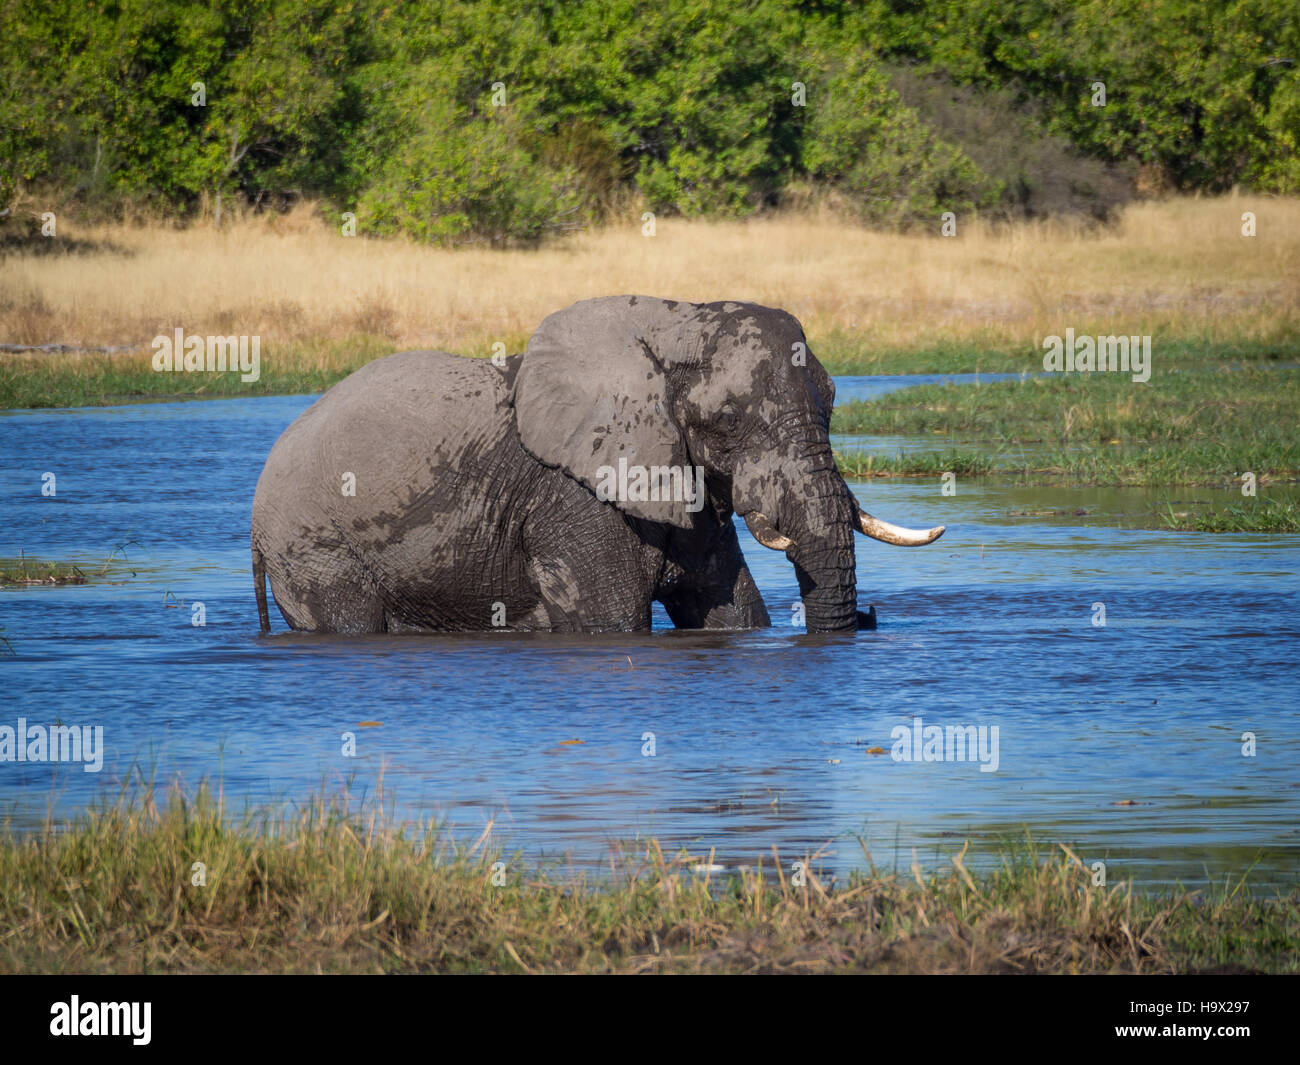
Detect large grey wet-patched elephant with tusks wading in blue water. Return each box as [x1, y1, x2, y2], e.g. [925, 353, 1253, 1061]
[251, 295, 944, 633]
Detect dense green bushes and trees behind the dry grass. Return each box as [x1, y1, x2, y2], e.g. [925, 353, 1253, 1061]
[0, 0, 1300, 242]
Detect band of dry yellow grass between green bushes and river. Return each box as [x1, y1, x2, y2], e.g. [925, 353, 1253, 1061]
[0, 196, 1300, 352]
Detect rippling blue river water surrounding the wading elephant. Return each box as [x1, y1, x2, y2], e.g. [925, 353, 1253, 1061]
[0, 375, 1300, 884]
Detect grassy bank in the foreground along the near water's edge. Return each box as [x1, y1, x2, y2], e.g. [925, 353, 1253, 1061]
[0, 791, 1300, 973]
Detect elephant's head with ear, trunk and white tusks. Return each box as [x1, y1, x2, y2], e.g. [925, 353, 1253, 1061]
[515, 296, 944, 632]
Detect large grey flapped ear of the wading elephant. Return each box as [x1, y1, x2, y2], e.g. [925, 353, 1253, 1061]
[514, 296, 699, 528]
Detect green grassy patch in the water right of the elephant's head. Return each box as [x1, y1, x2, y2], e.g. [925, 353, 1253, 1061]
[831, 365, 1300, 486]
